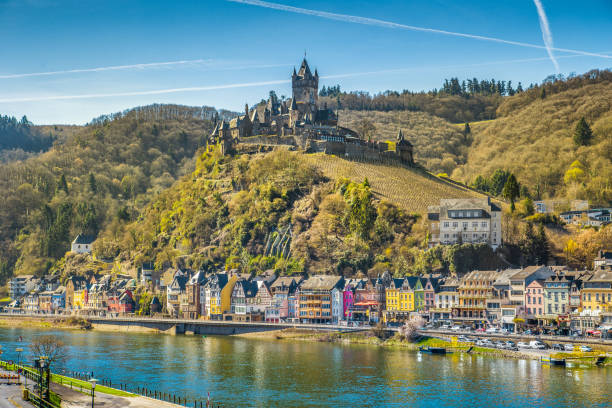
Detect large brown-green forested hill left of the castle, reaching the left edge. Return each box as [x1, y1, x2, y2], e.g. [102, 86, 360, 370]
[0, 106, 212, 280]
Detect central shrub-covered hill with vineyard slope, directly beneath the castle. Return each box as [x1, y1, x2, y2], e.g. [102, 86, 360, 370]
[94, 146, 492, 276]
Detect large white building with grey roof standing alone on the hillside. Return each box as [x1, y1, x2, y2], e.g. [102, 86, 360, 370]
[427, 198, 502, 249]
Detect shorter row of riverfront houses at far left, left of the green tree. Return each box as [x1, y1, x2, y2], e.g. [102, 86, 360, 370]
[9, 275, 137, 315]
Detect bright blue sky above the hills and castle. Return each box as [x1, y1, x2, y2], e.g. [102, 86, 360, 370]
[0, 0, 612, 124]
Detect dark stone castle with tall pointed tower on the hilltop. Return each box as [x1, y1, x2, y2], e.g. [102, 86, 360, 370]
[209, 58, 414, 165]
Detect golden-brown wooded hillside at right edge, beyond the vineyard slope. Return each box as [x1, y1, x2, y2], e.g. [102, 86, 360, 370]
[452, 71, 612, 205]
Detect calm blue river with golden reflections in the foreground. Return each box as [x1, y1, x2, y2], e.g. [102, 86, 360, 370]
[0, 328, 612, 407]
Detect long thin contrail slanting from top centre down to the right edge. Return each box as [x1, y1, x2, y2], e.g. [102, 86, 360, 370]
[226, 0, 612, 58]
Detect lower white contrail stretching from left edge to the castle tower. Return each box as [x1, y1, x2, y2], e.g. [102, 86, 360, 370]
[0, 79, 291, 103]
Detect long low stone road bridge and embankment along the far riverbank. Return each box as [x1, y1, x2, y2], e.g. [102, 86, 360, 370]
[0, 313, 370, 335]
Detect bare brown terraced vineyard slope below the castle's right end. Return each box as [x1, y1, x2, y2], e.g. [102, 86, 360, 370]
[304, 153, 481, 213]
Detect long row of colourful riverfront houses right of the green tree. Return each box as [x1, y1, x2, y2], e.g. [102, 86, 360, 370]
[161, 266, 612, 331]
